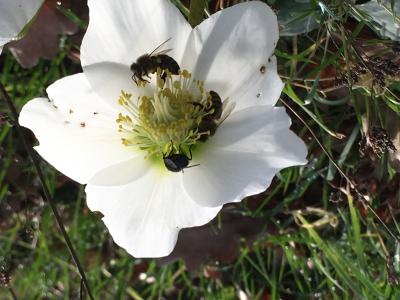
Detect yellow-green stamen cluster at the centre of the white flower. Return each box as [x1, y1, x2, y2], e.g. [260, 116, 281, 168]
[117, 69, 216, 156]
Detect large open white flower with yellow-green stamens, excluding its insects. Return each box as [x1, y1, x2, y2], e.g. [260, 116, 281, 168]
[20, 0, 306, 257]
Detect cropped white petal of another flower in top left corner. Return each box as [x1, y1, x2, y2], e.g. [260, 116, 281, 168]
[0, 0, 44, 54]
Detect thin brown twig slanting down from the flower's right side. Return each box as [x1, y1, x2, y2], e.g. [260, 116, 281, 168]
[279, 98, 400, 242]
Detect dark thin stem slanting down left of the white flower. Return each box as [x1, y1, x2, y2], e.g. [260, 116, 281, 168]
[0, 83, 94, 299]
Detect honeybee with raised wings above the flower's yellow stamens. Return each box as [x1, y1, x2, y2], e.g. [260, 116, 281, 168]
[131, 38, 180, 84]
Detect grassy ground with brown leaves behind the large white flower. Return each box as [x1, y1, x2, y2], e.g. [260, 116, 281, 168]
[0, 0, 400, 299]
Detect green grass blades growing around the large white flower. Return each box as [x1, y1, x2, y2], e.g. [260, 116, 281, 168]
[0, 0, 400, 299]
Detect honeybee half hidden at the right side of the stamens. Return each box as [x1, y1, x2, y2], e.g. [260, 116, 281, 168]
[197, 91, 235, 142]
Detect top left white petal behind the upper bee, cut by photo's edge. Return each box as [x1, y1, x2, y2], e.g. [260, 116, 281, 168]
[81, 0, 191, 104]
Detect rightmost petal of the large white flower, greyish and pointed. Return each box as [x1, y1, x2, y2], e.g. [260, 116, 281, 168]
[183, 106, 307, 207]
